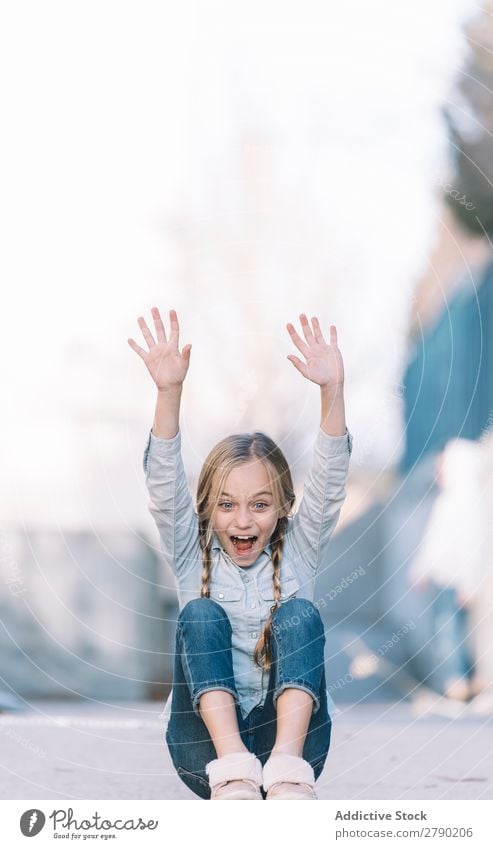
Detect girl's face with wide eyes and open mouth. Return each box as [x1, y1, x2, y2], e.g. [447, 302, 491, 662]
[212, 460, 286, 567]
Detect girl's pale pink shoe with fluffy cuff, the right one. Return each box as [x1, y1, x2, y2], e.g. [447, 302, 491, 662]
[263, 754, 317, 801]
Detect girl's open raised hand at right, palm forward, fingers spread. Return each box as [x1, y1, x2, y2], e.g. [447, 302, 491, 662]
[286, 313, 344, 389]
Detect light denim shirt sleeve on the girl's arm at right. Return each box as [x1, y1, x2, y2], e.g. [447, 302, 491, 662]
[291, 428, 353, 572]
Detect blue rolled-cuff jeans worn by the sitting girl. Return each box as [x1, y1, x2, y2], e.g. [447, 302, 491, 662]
[166, 598, 332, 799]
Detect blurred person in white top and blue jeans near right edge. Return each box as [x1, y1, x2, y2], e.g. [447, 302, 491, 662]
[409, 438, 489, 701]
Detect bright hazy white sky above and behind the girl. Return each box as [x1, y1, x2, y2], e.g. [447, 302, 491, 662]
[0, 0, 474, 526]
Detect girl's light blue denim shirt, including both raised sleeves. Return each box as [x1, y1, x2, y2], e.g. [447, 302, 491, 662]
[143, 428, 353, 719]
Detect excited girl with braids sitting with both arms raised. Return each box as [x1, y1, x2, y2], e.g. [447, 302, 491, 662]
[128, 307, 352, 800]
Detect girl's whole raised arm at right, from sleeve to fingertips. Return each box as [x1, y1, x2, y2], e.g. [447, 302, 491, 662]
[287, 314, 352, 572]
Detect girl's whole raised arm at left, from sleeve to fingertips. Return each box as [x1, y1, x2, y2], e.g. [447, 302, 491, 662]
[128, 307, 200, 575]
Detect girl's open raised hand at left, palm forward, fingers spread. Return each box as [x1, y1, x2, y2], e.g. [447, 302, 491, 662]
[128, 307, 192, 391]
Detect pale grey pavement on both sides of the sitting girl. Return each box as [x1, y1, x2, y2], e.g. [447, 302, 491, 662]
[0, 691, 493, 799]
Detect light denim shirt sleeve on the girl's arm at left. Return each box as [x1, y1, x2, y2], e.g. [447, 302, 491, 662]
[143, 431, 201, 577]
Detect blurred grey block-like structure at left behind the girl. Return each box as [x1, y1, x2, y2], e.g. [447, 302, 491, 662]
[0, 528, 176, 708]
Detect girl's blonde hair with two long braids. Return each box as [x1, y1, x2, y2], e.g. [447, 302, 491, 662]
[197, 431, 295, 670]
